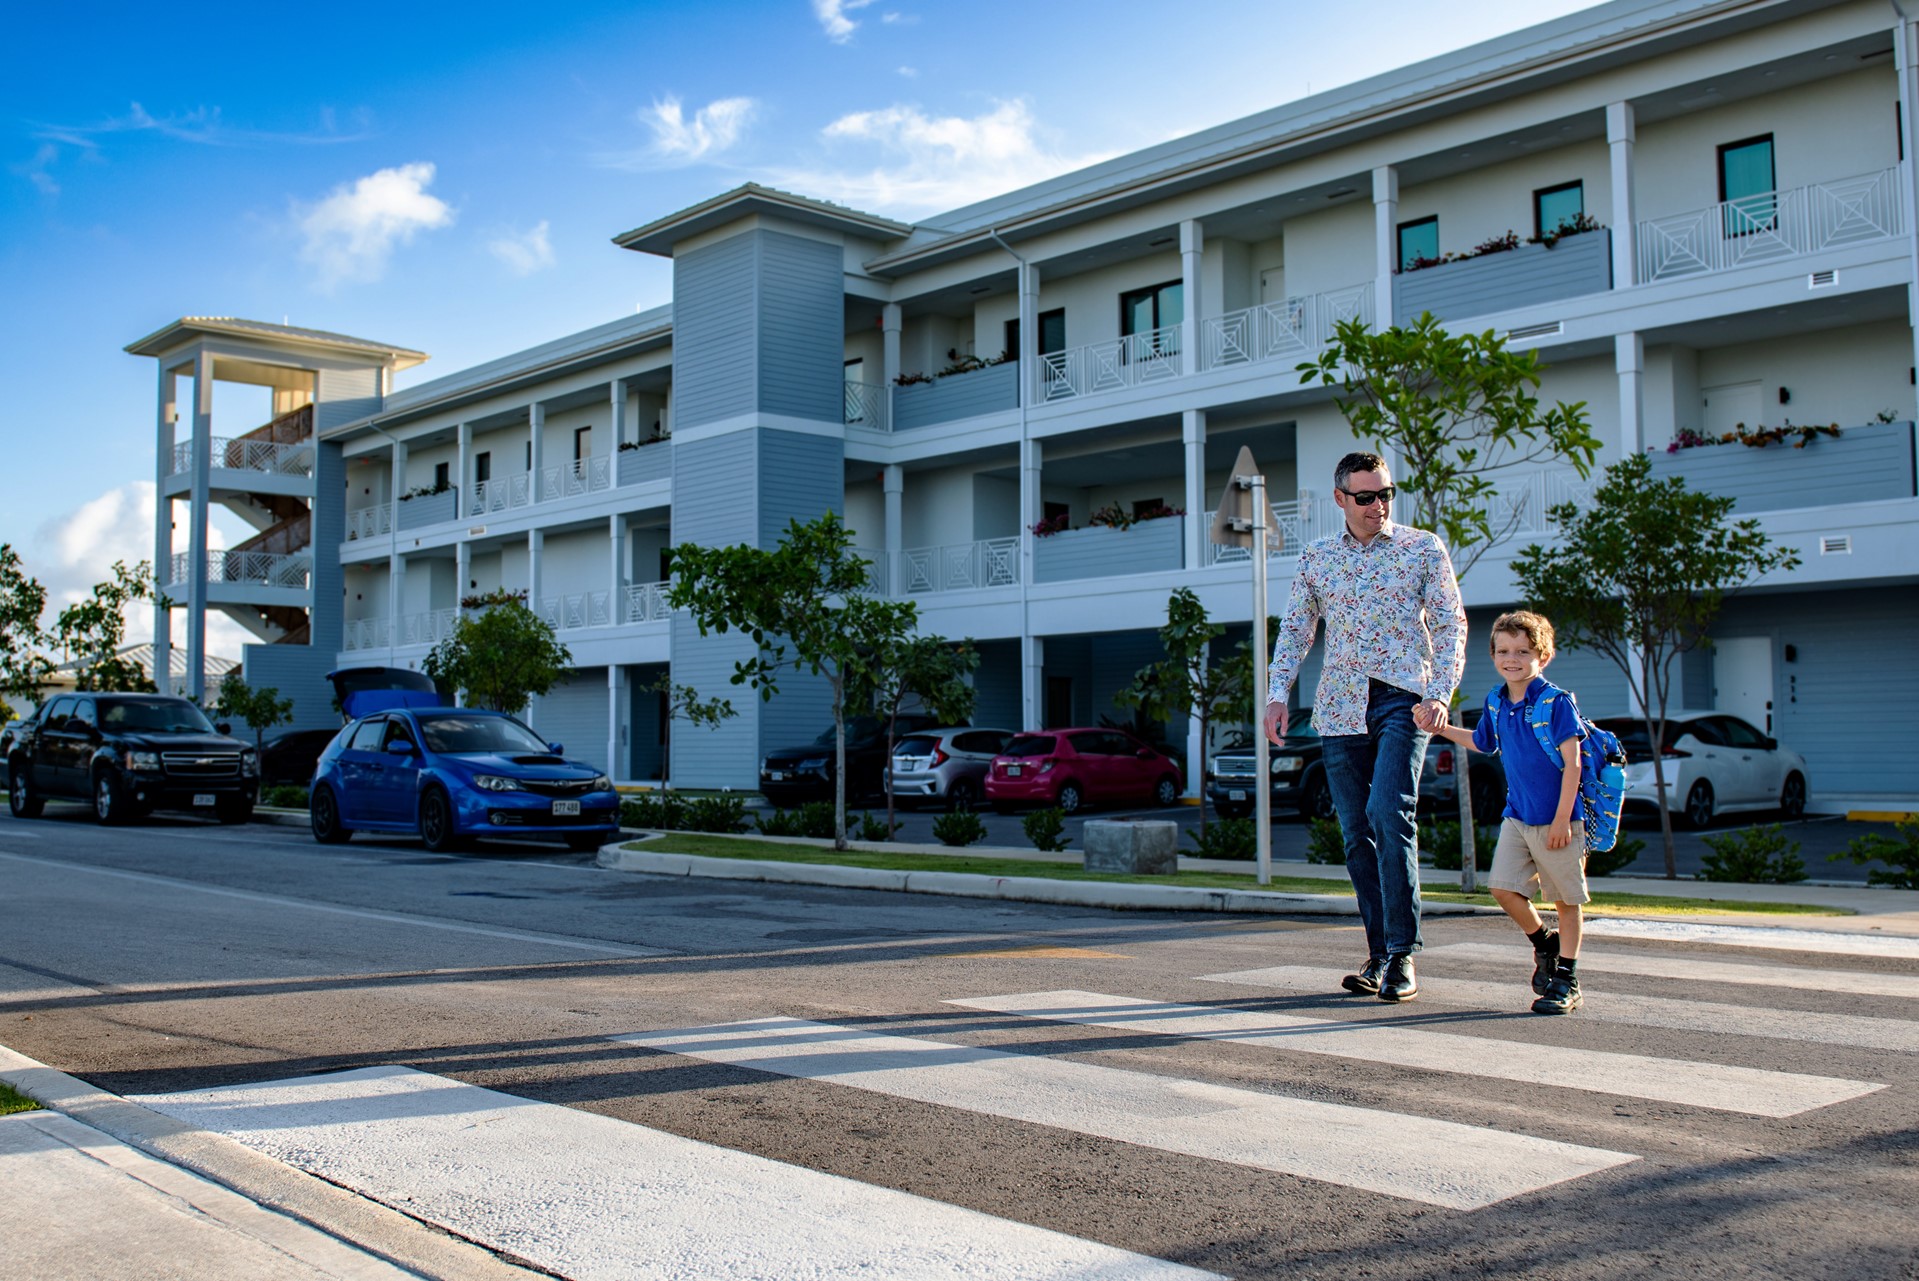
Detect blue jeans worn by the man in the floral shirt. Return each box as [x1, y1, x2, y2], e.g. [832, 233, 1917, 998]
[1320, 681, 1432, 957]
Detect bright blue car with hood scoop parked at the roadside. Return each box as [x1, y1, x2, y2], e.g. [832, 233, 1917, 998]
[311, 706, 620, 853]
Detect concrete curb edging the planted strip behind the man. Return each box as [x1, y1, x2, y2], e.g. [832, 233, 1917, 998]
[599, 846, 1503, 917]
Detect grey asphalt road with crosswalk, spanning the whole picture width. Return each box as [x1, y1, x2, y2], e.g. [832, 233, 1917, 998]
[0, 805, 1919, 1279]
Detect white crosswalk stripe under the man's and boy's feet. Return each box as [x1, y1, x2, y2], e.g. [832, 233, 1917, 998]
[1199, 966, 1919, 1053]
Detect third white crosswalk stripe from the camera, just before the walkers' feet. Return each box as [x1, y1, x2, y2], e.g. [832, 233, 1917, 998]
[948, 991, 1884, 1116]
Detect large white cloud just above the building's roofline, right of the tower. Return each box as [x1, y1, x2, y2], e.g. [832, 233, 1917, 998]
[770, 98, 1111, 213]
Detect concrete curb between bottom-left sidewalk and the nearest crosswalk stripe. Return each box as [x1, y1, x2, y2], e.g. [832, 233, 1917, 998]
[0, 1045, 553, 1281]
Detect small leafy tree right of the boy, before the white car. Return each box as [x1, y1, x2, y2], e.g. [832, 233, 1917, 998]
[1512, 444, 1800, 878]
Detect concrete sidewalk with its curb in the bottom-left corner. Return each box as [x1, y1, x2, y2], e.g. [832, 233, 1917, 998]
[0, 1045, 547, 1281]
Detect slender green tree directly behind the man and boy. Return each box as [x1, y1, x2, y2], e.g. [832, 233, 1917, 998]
[1299, 313, 1599, 886]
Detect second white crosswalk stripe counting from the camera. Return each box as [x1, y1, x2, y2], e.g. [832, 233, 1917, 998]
[612, 1018, 1637, 1210]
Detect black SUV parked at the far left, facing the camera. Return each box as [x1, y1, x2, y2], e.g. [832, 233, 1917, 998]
[6, 694, 259, 823]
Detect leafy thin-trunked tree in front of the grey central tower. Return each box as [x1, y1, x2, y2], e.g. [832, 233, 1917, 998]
[666, 512, 917, 850]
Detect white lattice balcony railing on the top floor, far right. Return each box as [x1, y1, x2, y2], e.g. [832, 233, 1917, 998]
[1639, 167, 1906, 284]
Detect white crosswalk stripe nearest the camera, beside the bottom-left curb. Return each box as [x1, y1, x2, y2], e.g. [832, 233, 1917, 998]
[138, 1068, 1213, 1281]
